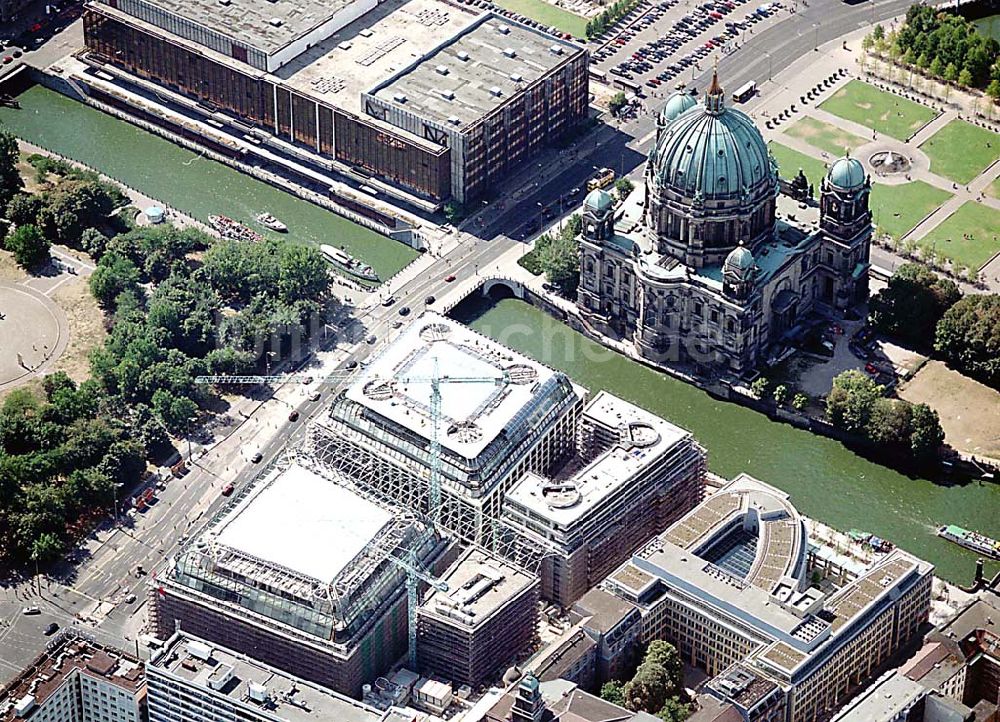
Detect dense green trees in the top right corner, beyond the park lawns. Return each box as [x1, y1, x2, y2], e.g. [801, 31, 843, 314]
[862, 4, 1000, 99]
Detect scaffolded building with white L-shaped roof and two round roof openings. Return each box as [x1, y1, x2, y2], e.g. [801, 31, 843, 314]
[504, 391, 706, 607]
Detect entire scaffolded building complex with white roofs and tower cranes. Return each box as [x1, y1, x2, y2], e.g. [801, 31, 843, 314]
[149, 313, 705, 711]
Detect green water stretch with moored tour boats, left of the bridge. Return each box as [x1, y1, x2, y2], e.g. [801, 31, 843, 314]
[0, 85, 417, 279]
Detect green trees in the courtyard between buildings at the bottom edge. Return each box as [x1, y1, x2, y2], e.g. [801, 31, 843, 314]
[601, 639, 691, 722]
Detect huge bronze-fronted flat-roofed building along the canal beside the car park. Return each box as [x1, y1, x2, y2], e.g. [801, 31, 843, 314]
[82, 0, 589, 204]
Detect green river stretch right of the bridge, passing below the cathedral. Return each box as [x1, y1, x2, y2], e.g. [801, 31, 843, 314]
[454, 299, 1000, 583]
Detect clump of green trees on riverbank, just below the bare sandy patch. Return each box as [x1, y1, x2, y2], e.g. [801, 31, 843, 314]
[826, 369, 944, 463]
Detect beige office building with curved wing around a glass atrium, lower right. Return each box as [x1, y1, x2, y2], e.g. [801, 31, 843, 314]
[604, 475, 933, 722]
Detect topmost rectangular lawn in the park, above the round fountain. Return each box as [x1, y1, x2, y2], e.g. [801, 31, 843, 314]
[819, 80, 937, 140]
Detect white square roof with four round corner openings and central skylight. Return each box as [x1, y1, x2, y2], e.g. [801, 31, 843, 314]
[347, 313, 556, 459]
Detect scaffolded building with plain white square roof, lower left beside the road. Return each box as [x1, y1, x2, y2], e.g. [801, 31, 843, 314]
[149, 463, 442, 696]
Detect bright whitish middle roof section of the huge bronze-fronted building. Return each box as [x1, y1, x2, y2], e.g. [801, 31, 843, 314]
[274, 0, 477, 113]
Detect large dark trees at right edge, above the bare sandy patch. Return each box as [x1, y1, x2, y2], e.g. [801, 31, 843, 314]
[869, 263, 1000, 389]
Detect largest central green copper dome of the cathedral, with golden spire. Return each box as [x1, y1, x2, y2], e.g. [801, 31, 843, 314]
[649, 73, 777, 200]
